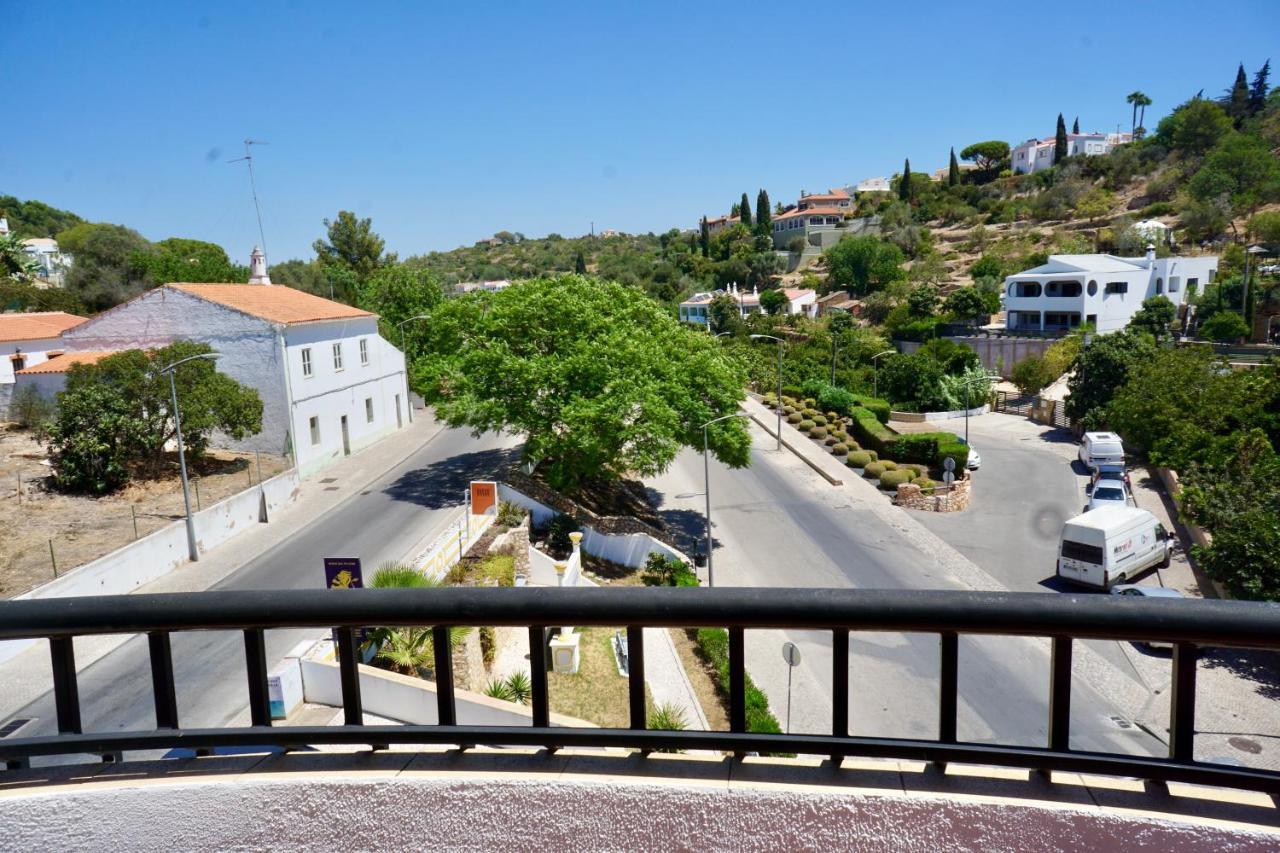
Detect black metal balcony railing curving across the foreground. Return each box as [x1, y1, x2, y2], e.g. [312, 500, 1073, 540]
[0, 588, 1280, 793]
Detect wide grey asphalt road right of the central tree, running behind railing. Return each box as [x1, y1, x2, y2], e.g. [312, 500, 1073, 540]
[650, 428, 1165, 753]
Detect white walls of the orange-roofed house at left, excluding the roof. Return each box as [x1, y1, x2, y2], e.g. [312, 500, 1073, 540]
[51, 284, 408, 476]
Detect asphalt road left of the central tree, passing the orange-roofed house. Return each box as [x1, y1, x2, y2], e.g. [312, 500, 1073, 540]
[13, 429, 516, 736]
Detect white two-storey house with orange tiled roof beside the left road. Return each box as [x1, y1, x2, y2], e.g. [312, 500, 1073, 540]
[15, 248, 411, 476]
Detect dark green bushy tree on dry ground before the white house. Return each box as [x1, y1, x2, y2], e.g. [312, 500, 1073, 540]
[50, 341, 262, 494]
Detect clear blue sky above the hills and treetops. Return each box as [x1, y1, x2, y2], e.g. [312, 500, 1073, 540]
[0, 0, 1280, 261]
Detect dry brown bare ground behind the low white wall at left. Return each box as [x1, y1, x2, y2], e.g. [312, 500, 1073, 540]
[0, 429, 288, 598]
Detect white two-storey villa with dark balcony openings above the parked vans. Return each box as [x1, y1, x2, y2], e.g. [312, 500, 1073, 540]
[1001, 247, 1217, 333]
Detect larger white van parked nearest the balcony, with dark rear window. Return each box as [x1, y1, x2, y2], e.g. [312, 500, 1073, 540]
[1057, 506, 1174, 589]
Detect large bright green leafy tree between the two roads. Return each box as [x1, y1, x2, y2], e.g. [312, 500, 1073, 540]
[413, 275, 750, 489]
